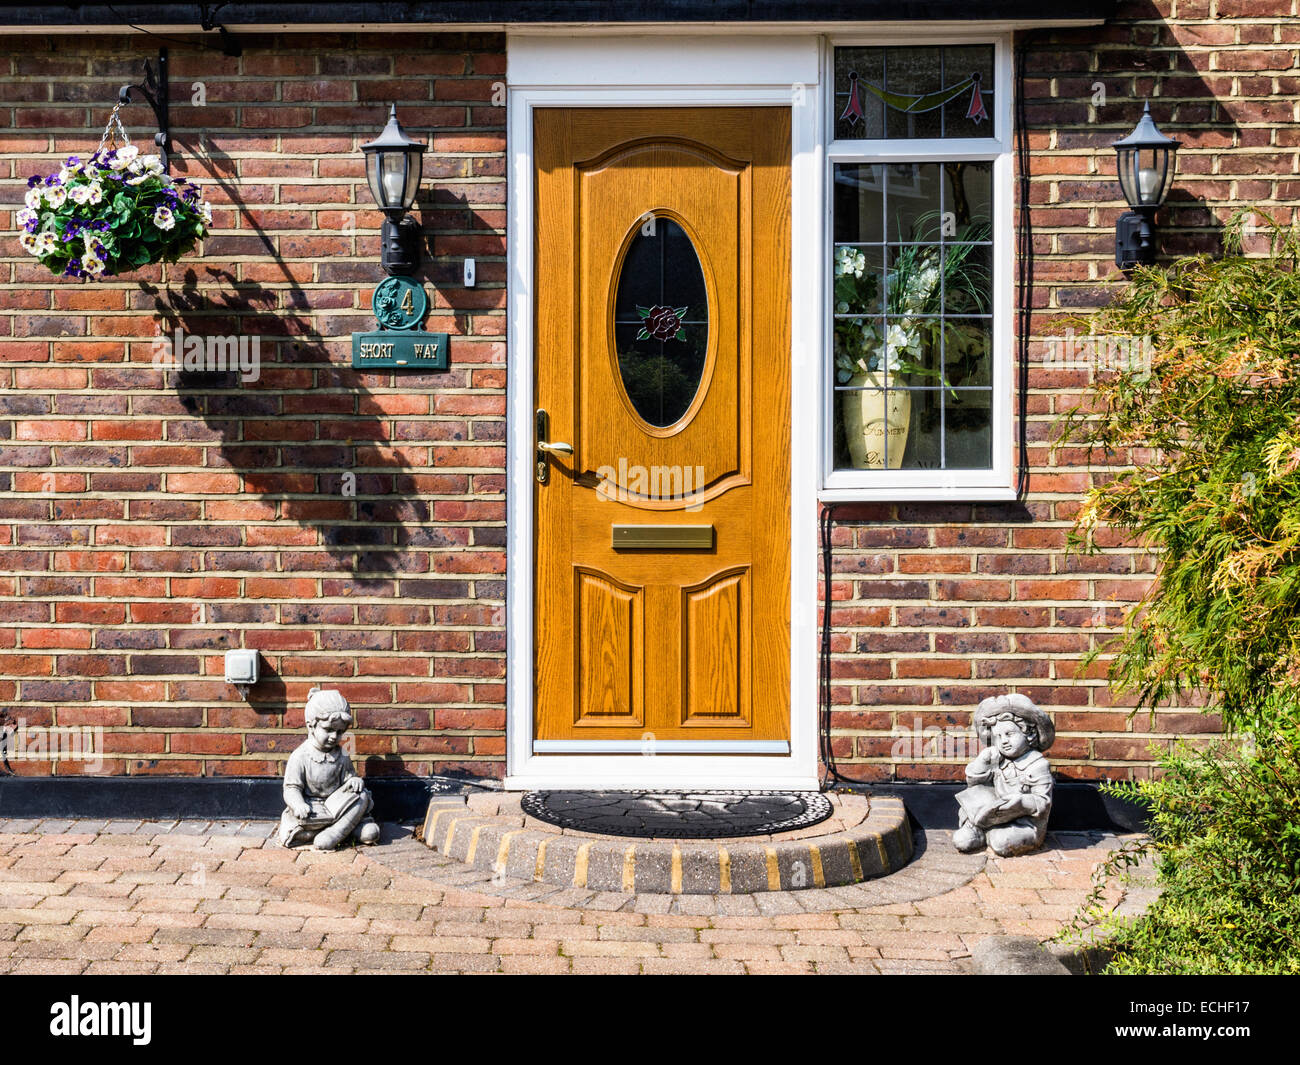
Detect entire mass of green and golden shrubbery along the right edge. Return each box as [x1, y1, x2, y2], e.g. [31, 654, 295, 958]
[1062, 212, 1300, 973]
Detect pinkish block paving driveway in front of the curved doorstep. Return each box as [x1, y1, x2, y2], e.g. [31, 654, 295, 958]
[0, 819, 1149, 974]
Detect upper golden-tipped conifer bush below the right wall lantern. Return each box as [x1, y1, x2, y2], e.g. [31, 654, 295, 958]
[1063, 211, 1300, 730]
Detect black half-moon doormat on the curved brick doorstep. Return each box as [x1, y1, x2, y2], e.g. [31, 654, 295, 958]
[520, 792, 832, 840]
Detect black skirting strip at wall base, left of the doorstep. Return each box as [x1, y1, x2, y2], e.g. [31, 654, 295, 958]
[0, 776, 460, 821]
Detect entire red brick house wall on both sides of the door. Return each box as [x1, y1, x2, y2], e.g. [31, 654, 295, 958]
[0, 0, 1300, 779]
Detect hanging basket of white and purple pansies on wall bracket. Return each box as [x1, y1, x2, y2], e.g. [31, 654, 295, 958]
[17, 104, 212, 278]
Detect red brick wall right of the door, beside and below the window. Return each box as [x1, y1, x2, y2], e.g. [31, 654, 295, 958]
[832, 0, 1300, 780]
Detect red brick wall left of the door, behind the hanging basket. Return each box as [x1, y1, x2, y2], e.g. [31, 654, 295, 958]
[0, 33, 506, 775]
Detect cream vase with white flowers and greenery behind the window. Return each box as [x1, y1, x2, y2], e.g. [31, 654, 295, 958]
[835, 222, 988, 469]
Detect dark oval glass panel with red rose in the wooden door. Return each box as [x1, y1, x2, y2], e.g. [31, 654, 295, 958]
[614, 217, 709, 428]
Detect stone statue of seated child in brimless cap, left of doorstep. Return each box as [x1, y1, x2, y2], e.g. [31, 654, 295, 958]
[280, 688, 380, 850]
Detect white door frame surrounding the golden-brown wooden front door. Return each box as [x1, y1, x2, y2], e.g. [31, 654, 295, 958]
[506, 27, 824, 789]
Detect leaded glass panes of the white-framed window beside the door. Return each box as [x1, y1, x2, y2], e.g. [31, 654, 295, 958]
[828, 44, 1004, 471]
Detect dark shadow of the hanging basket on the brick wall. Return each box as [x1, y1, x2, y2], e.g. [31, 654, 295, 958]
[142, 144, 432, 589]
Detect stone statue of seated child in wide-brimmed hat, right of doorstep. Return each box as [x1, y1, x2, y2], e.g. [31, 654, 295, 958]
[953, 696, 1056, 858]
